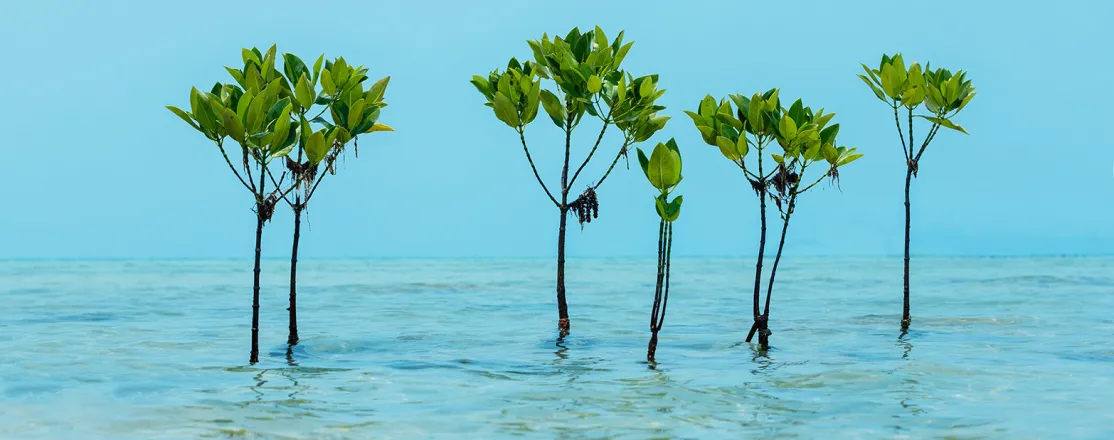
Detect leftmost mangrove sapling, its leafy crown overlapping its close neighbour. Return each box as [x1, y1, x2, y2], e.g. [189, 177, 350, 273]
[167, 46, 304, 363]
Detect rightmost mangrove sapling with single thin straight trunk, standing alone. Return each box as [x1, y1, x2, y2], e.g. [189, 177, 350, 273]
[859, 53, 976, 330]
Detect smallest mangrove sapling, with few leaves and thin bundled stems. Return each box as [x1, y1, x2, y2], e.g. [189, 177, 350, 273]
[638, 139, 684, 362]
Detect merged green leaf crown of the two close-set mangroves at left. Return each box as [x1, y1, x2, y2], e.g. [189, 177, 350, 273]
[167, 46, 392, 173]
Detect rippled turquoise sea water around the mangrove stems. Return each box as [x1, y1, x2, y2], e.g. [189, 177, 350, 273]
[0, 258, 1114, 439]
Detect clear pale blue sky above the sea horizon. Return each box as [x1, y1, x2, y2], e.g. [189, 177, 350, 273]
[0, 0, 1114, 258]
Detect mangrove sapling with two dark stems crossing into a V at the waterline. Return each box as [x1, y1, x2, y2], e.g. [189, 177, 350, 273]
[685, 89, 862, 350]
